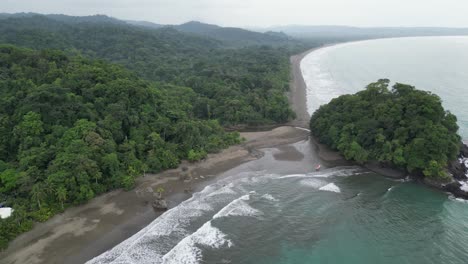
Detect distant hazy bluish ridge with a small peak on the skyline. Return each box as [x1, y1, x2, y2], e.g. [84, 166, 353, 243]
[173, 21, 289, 46]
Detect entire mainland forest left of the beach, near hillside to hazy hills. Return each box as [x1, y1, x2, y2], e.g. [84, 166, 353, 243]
[0, 15, 314, 248]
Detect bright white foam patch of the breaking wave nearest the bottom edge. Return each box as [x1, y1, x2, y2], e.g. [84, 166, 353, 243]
[162, 221, 233, 264]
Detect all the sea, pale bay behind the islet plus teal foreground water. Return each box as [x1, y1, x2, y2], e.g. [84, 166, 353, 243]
[89, 38, 468, 264]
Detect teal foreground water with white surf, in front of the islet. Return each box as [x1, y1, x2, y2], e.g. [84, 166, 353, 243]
[89, 141, 468, 263]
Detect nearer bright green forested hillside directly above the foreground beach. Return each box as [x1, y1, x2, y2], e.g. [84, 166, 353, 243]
[0, 45, 240, 248]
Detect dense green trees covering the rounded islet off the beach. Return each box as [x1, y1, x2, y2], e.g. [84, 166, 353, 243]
[310, 80, 460, 181]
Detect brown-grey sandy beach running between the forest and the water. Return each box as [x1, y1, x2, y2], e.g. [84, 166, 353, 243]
[0, 48, 347, 264]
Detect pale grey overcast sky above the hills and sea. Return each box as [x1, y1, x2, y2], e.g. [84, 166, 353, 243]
[0, 0, 468, 27]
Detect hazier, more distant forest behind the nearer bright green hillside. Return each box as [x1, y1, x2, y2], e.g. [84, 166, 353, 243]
[0, 15, 305, 125]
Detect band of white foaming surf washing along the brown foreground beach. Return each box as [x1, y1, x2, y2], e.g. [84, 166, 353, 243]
[88, 167, 359, 264]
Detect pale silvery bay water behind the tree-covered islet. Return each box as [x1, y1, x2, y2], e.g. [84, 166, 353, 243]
[301, 37, 468, 140]
